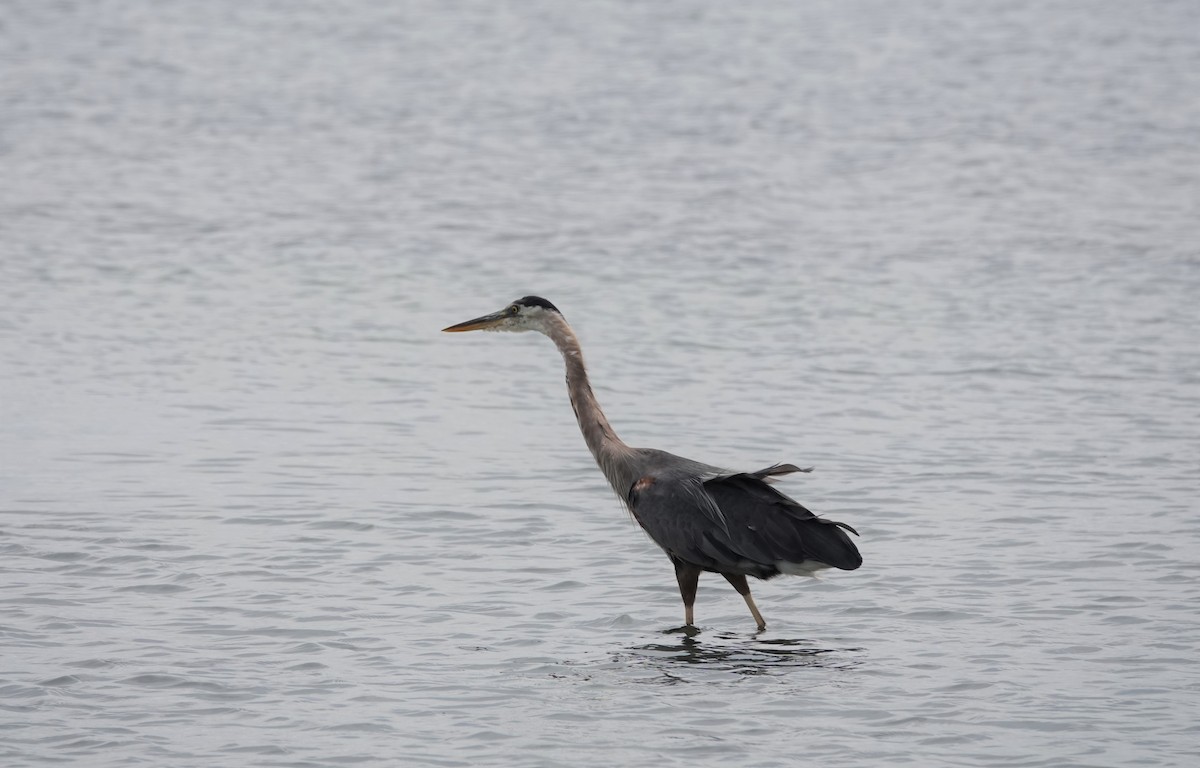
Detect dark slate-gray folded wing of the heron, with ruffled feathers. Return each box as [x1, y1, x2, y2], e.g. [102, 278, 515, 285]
[626, 464, 863, 578]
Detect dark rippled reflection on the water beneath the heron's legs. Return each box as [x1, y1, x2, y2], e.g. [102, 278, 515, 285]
[622, 626, 863, 679]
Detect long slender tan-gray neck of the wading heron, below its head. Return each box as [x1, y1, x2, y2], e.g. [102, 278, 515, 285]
[546, 313, 634, 496]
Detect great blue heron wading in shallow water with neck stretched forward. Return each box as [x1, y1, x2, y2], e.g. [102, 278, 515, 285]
[443, 296, 863, 630]
